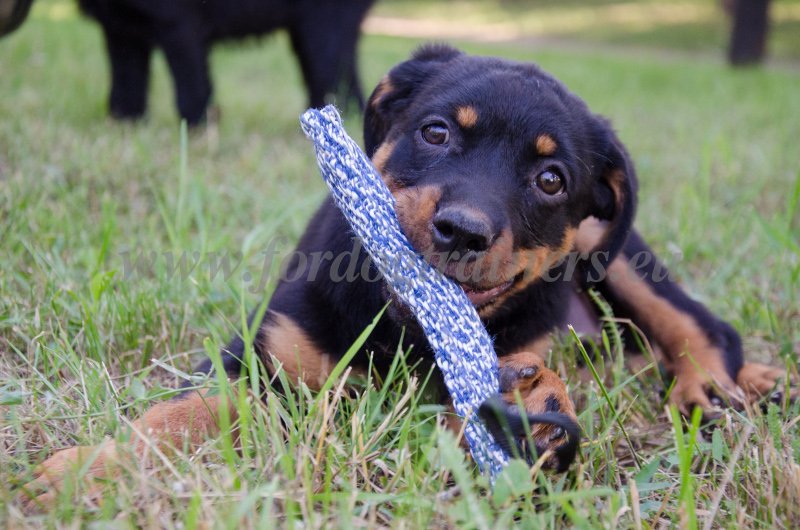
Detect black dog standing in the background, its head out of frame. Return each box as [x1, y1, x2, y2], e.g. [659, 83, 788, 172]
[78, 0, 375, 124]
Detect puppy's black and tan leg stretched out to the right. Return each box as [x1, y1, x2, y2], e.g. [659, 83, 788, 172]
[578, 219, 794, 419]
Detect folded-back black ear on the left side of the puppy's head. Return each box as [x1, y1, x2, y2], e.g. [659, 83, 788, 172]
[364, 44, 462, 157]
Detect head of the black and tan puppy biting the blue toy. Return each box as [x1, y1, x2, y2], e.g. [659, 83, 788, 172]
[364, 46, 636, 316]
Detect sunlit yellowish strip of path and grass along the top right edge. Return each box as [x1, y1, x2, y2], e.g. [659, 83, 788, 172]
[375, 0, 800, 64]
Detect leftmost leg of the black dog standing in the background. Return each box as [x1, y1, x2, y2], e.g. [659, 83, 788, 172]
[103, 27, 153, 120]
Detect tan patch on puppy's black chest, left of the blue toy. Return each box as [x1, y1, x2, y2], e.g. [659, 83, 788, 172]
[264, 312, 336, 390]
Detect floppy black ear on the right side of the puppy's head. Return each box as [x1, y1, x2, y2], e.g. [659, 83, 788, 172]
[587, 118, 639, 283]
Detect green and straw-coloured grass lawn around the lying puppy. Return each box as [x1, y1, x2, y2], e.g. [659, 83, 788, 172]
[0, 3, 800, 528]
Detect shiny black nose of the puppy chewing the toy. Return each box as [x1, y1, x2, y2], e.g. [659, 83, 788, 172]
[433, 206, 494, 257]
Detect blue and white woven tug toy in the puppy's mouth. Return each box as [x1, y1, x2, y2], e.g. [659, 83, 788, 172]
[300, 105, 507, 477]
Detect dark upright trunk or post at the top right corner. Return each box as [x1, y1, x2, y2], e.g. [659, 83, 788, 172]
[728, 0, 769, 66]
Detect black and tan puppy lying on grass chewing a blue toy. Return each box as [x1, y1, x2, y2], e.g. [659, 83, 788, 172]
[20, 46, 784, 500]
